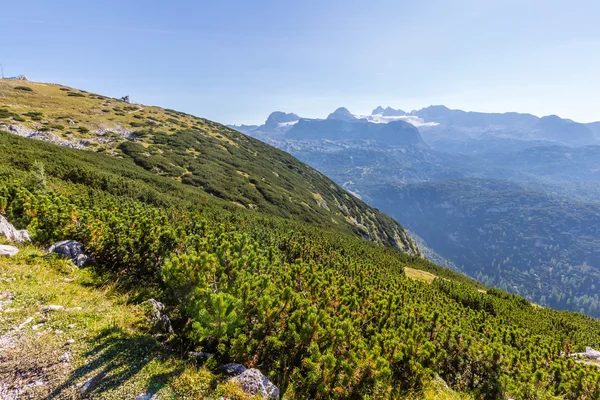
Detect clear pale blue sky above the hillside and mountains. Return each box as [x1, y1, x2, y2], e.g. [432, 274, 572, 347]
[0, 0, 600, 123]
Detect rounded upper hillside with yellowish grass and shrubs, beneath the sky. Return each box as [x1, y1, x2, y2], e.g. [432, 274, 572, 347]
[0, 80, 419, 254]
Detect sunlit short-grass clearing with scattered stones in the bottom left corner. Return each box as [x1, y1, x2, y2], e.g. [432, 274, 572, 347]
[0, 241, 262, 400]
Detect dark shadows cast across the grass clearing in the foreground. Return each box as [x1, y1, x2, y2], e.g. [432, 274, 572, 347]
[47, 327, 181, 399]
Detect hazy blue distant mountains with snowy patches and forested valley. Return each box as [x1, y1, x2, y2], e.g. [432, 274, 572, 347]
[229, 106, 600, 316]
